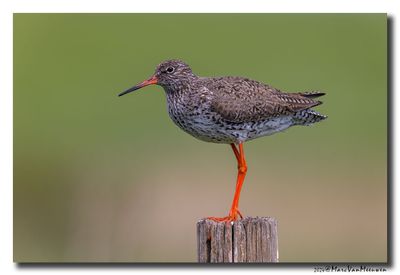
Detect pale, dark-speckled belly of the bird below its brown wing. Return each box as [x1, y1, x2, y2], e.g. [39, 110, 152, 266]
[170, 109, 293, 146]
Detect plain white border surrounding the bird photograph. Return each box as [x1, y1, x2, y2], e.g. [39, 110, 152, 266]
[0, 0, 400, 274]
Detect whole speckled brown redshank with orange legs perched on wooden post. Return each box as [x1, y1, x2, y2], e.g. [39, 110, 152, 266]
[119, 60, 327, 222]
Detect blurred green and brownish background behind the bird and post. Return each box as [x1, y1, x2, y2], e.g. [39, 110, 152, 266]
[14, 14, 387, 262]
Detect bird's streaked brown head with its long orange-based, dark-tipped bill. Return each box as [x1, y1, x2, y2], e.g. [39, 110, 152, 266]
[118, 60, 196, 96]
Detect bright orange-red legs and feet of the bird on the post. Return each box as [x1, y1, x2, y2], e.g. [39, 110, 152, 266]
[208, 143, 247, 222]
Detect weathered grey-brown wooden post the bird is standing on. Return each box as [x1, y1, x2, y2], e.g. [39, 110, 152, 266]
[197, 217, 279, 263]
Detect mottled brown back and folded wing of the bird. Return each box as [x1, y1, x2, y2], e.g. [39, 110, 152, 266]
[201, 77, 324, 123]
